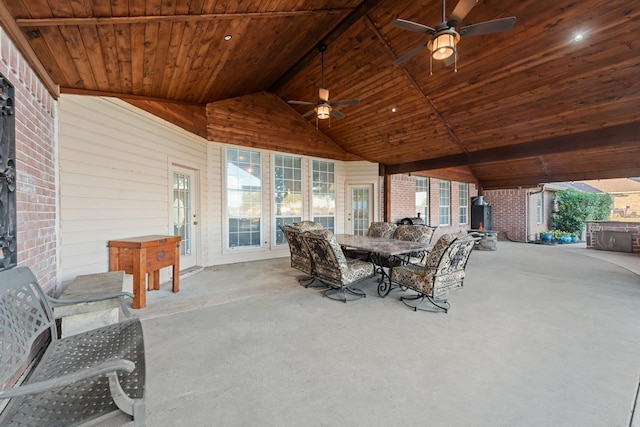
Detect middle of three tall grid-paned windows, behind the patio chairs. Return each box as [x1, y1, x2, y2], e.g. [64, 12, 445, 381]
[273, 154, 302, 245]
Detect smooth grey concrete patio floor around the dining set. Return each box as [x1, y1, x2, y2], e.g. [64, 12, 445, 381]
[136, 242, 640, 427]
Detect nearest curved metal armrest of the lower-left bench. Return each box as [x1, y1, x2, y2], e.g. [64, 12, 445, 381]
[0, 359, 136, 399]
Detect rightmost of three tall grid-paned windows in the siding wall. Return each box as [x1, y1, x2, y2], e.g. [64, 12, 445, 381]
[311, 160, 336, 232]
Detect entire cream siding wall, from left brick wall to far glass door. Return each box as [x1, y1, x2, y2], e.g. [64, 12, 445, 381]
[60, 95, 380, 281]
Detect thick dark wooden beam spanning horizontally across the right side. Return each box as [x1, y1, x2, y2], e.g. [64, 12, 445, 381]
[385, 122, 640, 174]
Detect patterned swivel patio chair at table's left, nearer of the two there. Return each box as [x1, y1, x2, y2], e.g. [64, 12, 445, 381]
[302, 230, 375, 302]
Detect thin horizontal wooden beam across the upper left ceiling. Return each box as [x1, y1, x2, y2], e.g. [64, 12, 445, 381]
[15, 8, 351, 28]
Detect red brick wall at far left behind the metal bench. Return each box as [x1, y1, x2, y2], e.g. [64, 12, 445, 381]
[0, 27, 58, 290]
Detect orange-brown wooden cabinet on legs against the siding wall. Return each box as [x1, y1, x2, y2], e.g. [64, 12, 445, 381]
[108, 235, 180, 308]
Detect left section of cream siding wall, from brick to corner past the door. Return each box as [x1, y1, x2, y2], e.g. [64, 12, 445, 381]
[60, 95, 208, 281]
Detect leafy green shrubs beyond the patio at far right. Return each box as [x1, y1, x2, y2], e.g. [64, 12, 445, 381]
[553, 190, 612, 236]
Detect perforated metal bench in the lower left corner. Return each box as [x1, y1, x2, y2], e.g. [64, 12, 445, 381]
[0, 267, 145, 426]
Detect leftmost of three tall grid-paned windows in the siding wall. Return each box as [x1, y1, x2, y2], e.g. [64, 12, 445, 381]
[226, 147, 262, 249]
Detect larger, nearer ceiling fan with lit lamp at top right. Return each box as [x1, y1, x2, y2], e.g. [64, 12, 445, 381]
[391, 0, 516, 74]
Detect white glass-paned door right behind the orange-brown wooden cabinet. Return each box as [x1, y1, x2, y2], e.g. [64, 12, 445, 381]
[172, 167, 198, 270]
